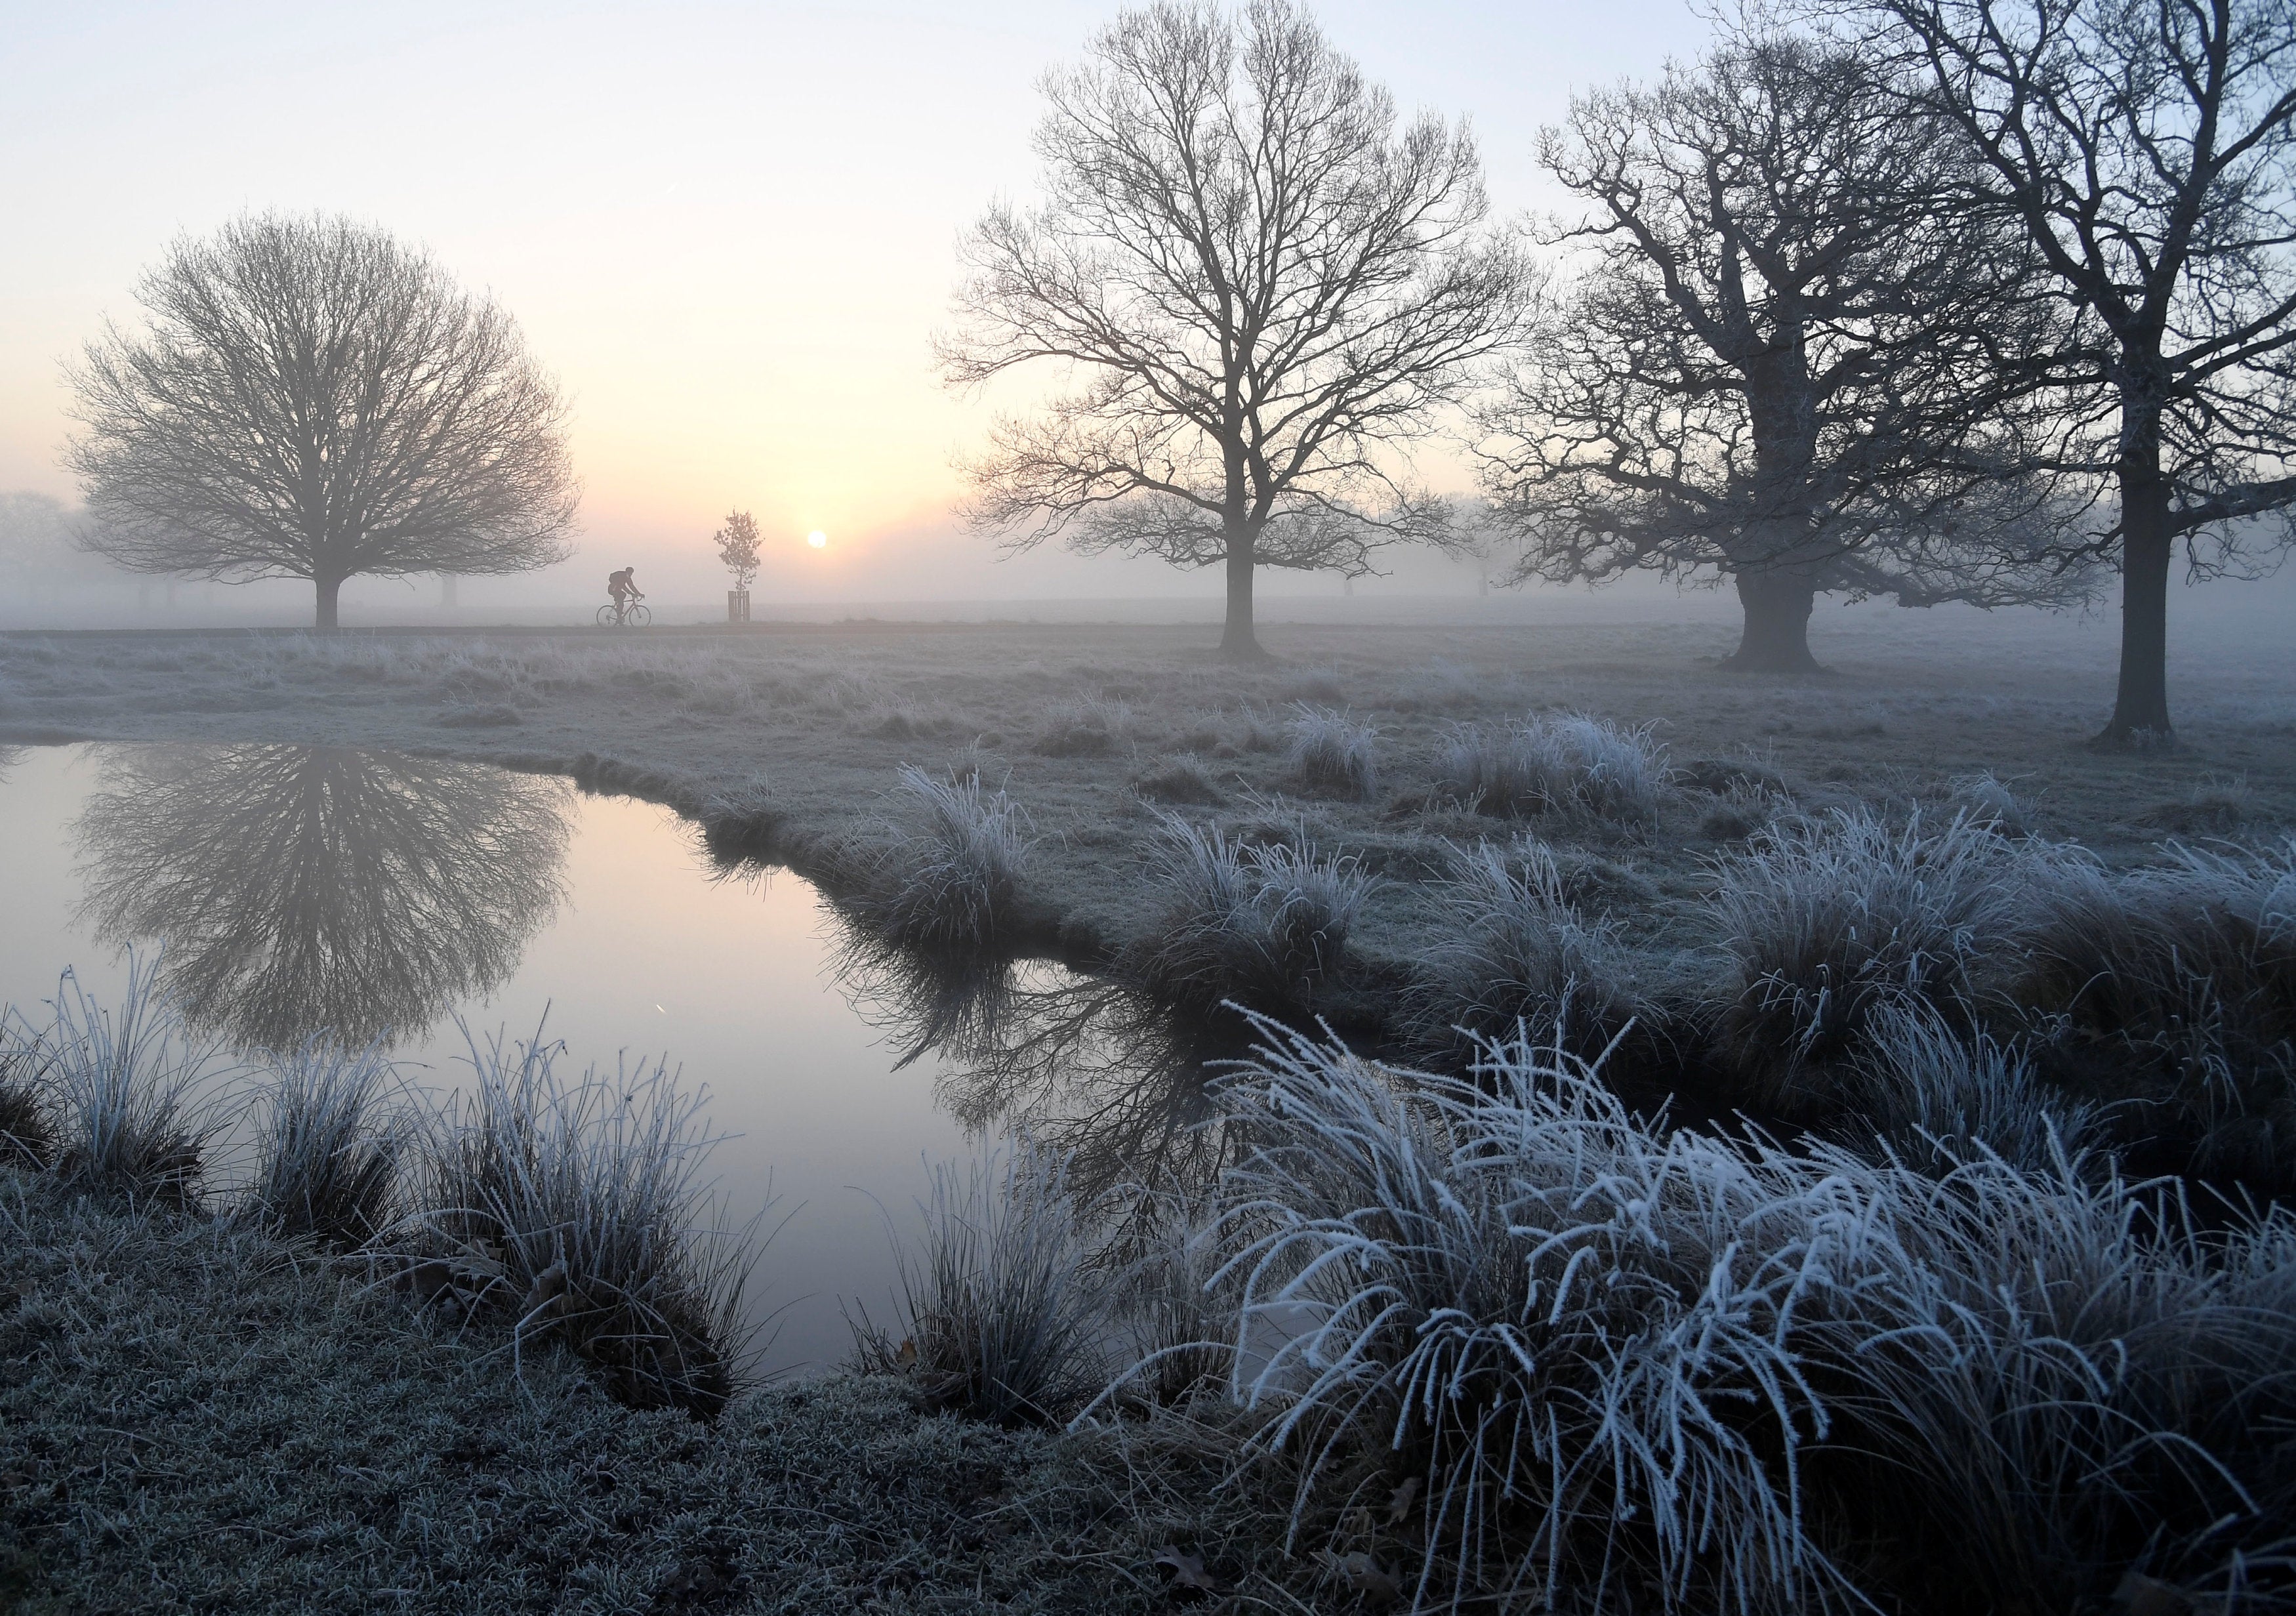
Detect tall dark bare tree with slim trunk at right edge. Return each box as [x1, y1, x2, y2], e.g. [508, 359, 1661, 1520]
[1853, 0, 2296, 744]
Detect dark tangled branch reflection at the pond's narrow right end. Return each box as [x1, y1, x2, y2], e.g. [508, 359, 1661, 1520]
[838, 921, 1249, 1203]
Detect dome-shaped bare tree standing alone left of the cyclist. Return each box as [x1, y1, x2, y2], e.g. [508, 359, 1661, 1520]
[64, 213, 579, 629]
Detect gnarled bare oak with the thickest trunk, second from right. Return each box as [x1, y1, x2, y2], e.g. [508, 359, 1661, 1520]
[1483, 37, 2078, 671]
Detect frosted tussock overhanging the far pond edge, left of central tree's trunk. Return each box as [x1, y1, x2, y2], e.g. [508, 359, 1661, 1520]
[859, 764, 1031, 948]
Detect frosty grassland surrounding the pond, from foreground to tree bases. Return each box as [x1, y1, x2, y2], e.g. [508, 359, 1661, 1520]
[0, 611, 2296, 1616]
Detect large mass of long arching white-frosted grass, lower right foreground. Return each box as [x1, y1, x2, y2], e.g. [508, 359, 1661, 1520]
[1224, 1026, 2296, 1611]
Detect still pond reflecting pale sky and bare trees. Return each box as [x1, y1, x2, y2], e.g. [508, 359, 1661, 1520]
[0, 746, 1221, 1371]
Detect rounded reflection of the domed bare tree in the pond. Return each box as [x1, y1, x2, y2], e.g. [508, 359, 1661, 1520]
[78, 746, 569, 1049]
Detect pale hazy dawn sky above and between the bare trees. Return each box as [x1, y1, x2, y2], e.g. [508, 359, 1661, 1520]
[0, 0, 1706, 597]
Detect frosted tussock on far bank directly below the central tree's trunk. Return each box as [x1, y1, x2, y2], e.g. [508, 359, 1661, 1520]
[1123, 815, 1373, 1008]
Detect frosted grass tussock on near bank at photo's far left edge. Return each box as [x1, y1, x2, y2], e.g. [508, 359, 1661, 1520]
[7, 955, 223, 1205]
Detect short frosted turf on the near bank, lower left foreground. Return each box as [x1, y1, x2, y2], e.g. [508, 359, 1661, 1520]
[0, 1173, 1313, 1616]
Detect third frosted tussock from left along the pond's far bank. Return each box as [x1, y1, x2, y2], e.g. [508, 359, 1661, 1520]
[1405, 838, 1649, 1056]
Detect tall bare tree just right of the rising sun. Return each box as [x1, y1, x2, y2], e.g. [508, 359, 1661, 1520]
[941, 0, 1529, 657]
